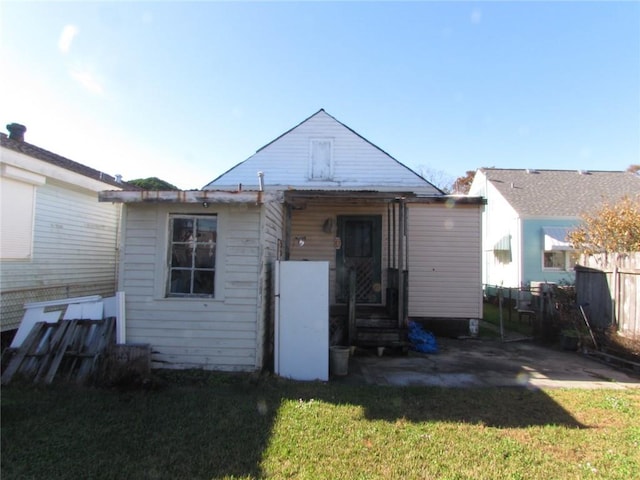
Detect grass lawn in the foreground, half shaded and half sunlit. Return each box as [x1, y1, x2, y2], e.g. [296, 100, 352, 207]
[1, 372, 640, 480]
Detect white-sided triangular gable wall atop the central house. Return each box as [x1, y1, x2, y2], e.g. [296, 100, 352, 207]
[204, 109, 444, 195]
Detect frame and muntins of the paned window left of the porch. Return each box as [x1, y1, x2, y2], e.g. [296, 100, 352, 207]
[164, 213, 220, 299]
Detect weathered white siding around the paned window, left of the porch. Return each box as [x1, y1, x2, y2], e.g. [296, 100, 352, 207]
[121, 200, 281, 371]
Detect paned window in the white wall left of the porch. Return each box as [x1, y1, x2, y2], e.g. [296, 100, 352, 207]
[167, 215, 218, 297]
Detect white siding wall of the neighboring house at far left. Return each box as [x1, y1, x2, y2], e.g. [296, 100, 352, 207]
[0, 179, 121, 331]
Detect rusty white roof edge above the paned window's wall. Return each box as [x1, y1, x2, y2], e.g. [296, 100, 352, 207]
[98, 190, 283, 205]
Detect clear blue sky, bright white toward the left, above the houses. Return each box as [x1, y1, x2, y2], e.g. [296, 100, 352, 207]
[0, 0, 640, 189]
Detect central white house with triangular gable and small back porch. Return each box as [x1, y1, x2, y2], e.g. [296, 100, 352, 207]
[100, 110, 483, 371]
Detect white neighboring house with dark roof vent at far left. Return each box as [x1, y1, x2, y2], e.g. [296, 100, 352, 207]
[0, 124, 123, 345]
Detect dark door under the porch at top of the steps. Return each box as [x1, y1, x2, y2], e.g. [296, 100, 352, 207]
[336, 215, 382, 303]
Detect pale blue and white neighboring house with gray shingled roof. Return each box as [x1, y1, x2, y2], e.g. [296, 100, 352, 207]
[469, 168, 640, 288]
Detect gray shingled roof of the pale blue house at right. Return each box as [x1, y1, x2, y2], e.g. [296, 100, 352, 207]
[480, 168, 640, 217]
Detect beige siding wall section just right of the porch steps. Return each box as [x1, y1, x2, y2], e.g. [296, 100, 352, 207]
[408, 204, 482, 318]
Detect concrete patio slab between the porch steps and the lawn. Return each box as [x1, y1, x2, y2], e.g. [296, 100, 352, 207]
[332, 338, 640, 389]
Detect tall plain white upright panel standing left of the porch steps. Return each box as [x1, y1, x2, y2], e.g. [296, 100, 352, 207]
[274, 261, 329, 381]
